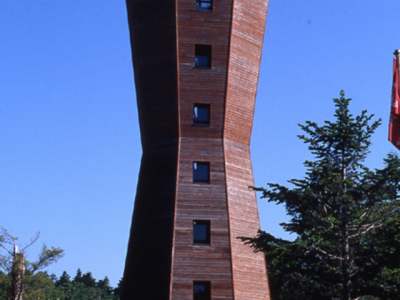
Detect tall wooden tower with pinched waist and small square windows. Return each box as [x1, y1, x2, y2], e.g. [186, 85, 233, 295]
[122, 0, 269, 300]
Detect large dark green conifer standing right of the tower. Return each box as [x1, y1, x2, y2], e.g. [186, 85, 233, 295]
[242, 91, 400, 300]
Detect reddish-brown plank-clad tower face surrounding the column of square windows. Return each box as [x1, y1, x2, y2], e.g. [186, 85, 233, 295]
[170, 0, 233, 300]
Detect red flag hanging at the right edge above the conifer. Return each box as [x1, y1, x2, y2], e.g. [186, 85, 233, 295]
[389, 55, 400, 150]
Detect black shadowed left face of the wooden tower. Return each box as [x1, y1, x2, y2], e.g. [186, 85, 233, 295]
[121, 0, 179, 300]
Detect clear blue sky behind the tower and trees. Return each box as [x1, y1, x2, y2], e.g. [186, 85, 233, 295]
[0, 0, 400, 285]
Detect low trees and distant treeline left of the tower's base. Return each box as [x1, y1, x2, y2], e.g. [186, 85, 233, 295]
[0, 228, 122, 300]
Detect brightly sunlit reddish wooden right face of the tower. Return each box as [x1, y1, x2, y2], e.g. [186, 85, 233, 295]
[224, 0, 270, 300]
